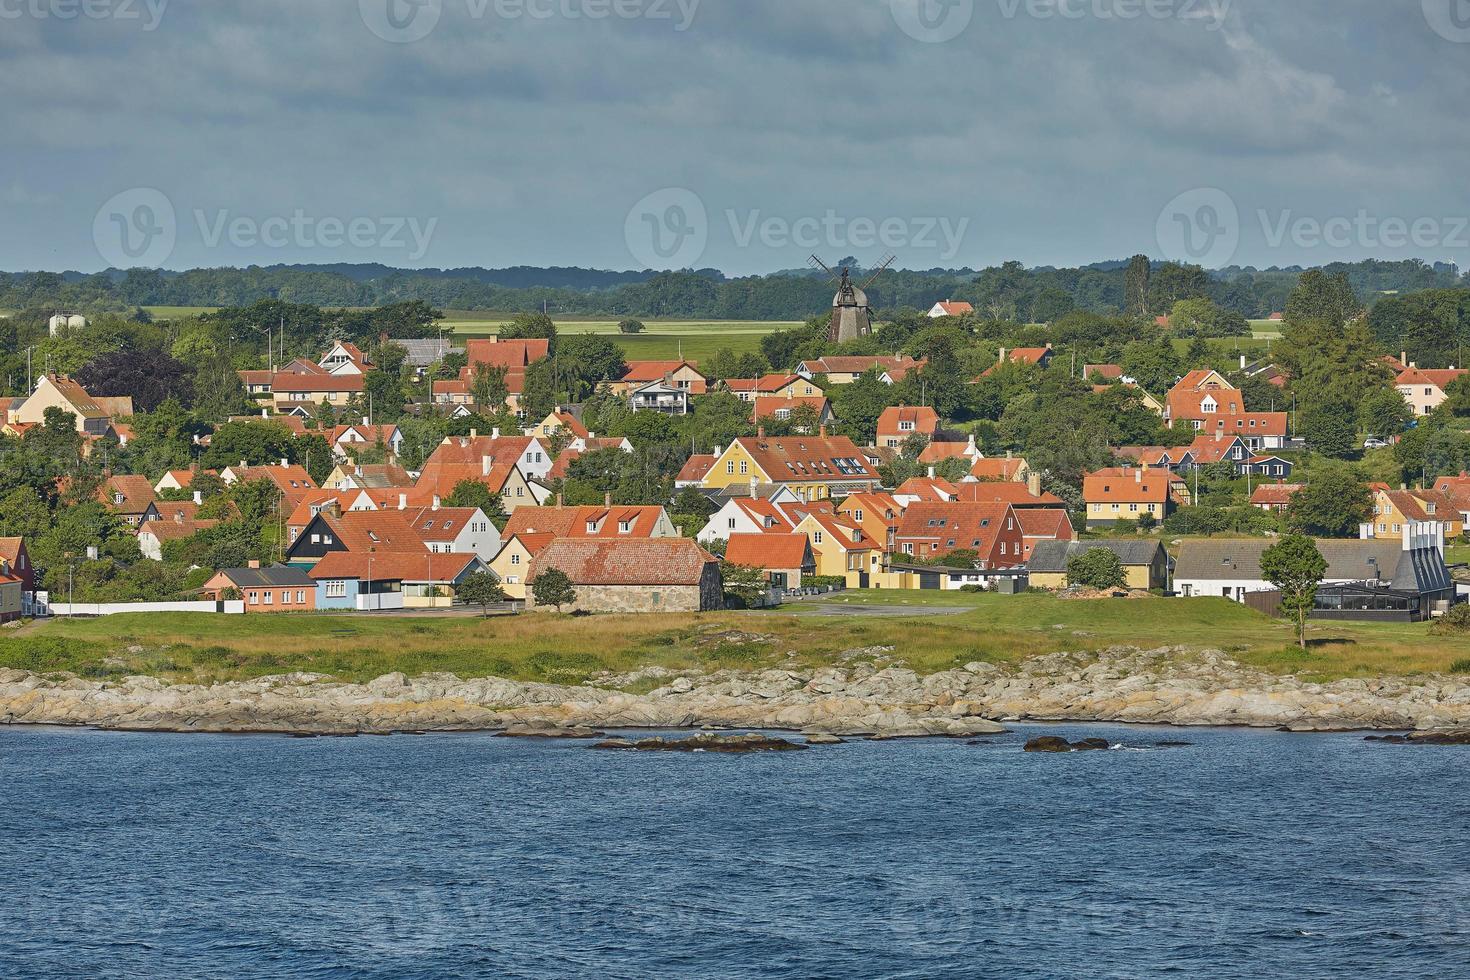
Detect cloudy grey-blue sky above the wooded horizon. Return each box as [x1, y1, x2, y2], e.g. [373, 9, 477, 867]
[0, 0, 1470, 275]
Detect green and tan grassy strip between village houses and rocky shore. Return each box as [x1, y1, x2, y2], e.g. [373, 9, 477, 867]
[0, 592, 1470, 683]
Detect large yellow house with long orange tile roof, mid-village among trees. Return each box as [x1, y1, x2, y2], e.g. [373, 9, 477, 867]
[701, 429, 882, 501]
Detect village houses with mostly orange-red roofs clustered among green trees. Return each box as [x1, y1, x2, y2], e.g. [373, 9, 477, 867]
[0, 326, 1470, 617]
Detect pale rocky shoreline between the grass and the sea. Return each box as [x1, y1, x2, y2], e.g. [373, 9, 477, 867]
[0, 649, 1470, 738]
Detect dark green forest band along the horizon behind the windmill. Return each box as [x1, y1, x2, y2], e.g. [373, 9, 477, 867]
[0, 257, 1467, 323]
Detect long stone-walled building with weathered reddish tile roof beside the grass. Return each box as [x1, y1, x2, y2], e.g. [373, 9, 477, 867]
[528, 538, 725, 613]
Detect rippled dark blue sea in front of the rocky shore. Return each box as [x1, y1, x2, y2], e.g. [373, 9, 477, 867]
[0, 726, 1470, 979]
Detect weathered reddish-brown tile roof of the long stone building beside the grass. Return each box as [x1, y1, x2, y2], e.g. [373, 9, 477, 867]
[529, 538, 719, 586]
